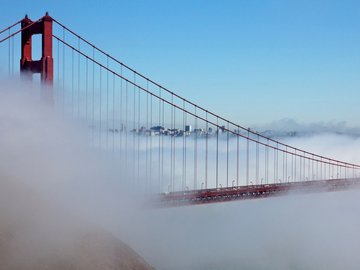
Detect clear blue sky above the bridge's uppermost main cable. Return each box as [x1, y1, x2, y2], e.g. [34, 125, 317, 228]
[0, 0, 360, 126]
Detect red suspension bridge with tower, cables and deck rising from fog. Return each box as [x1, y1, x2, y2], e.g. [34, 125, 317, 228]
[0, 13, 360, 206]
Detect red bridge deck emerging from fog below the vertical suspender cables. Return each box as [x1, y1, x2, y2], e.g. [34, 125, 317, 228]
[156, 178, 360, 207]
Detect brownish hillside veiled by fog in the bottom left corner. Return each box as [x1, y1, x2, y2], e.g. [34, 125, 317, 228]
[0, 175, 153, 270]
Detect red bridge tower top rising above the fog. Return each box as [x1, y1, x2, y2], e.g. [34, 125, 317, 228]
[20, 12, 54, 85]
